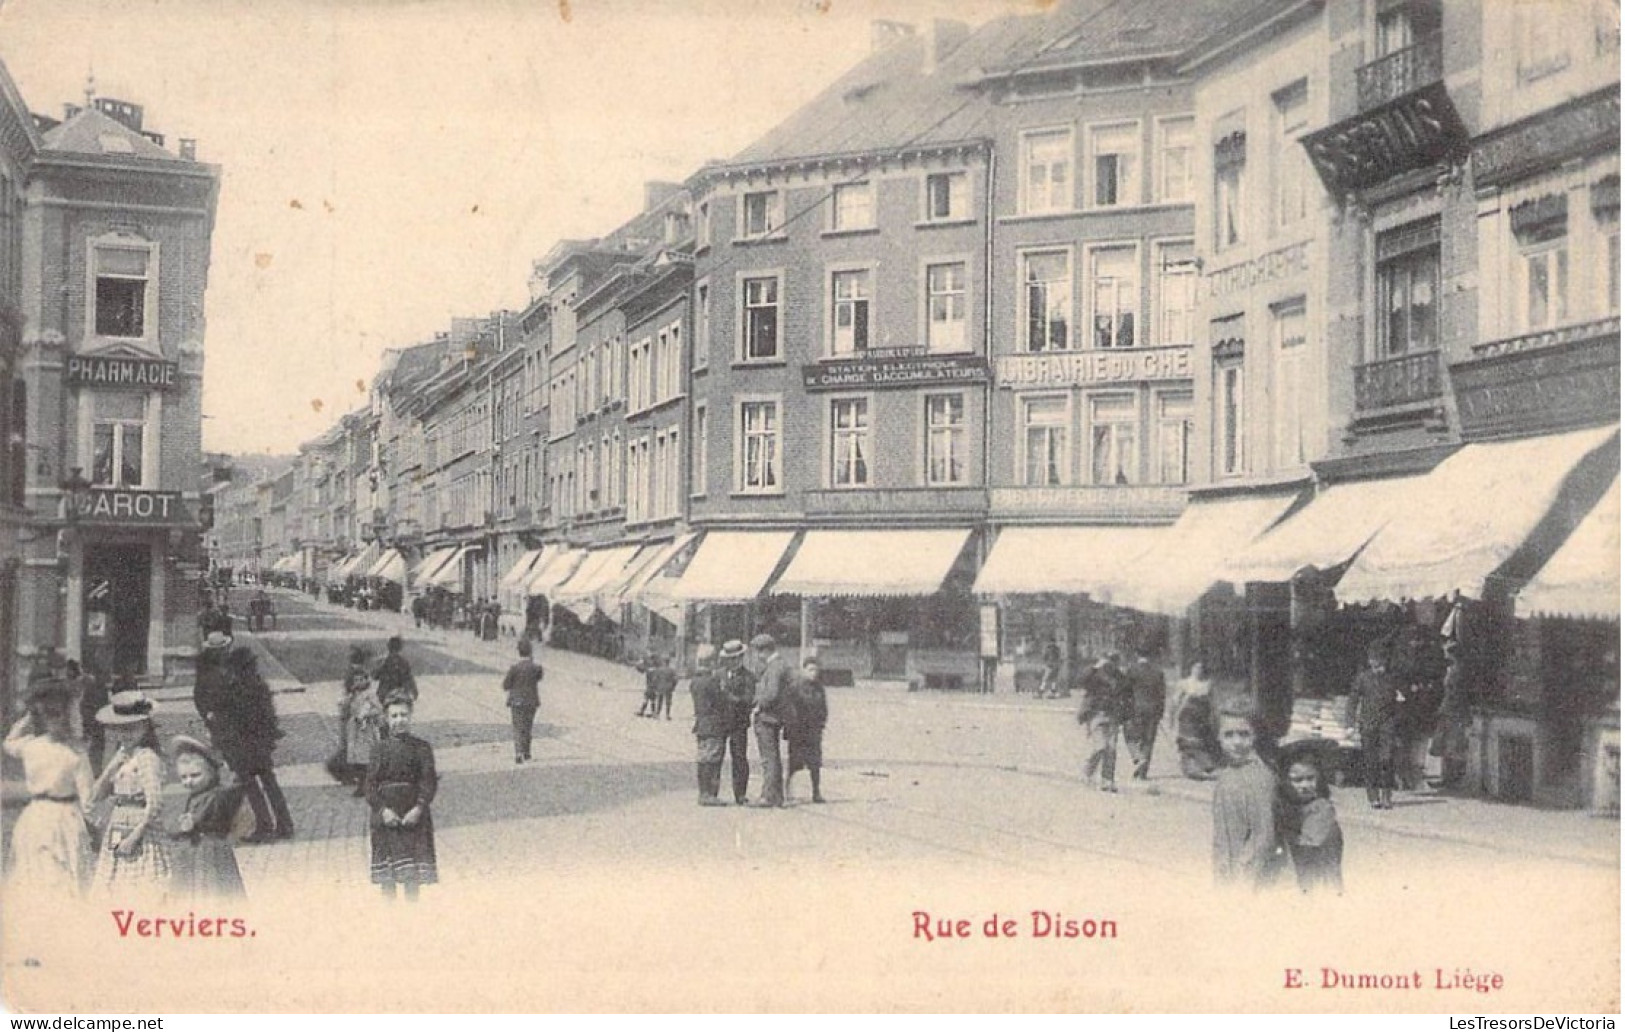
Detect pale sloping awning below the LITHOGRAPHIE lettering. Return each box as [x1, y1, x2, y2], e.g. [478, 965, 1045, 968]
[1102, 492, 1298, 616]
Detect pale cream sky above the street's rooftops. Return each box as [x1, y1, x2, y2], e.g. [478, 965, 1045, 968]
[0, 0, 1020, 452]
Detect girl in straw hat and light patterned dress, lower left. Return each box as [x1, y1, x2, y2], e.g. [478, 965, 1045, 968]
[91, 691, 169, 897]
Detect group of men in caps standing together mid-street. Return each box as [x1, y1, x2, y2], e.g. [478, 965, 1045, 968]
[685, 634, 829, 808]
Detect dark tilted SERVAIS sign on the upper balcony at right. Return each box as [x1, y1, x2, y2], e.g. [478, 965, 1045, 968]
[1303, 83, 1467, 195]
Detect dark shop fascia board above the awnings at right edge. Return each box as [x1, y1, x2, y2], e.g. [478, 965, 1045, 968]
[1450, 335, 1620, 440]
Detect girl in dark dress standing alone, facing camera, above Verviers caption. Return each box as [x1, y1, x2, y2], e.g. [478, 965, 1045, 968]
[367, 696, 439, 900]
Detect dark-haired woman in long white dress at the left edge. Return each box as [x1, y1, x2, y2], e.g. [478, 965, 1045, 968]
[5, 681, 93, 899]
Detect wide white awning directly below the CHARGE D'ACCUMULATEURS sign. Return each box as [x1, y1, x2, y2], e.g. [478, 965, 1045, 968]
[774, 530, 970, 598]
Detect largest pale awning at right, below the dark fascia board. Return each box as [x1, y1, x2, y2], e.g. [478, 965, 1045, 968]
[1336, 426, 1619, 603]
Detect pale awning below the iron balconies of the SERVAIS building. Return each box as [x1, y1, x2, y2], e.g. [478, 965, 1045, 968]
[1219, 476, 1427, 583]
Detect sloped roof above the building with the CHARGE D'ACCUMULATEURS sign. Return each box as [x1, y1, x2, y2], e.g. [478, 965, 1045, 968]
[726, 16, 1043, 166]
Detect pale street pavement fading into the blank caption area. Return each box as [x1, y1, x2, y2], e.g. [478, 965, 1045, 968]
[8, 592, 1620, 1009]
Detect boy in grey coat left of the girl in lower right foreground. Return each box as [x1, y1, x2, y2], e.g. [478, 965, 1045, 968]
[1212, 699, 1282, 891]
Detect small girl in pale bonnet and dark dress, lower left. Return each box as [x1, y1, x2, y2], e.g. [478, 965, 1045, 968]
[169, 735, 244, 900]
